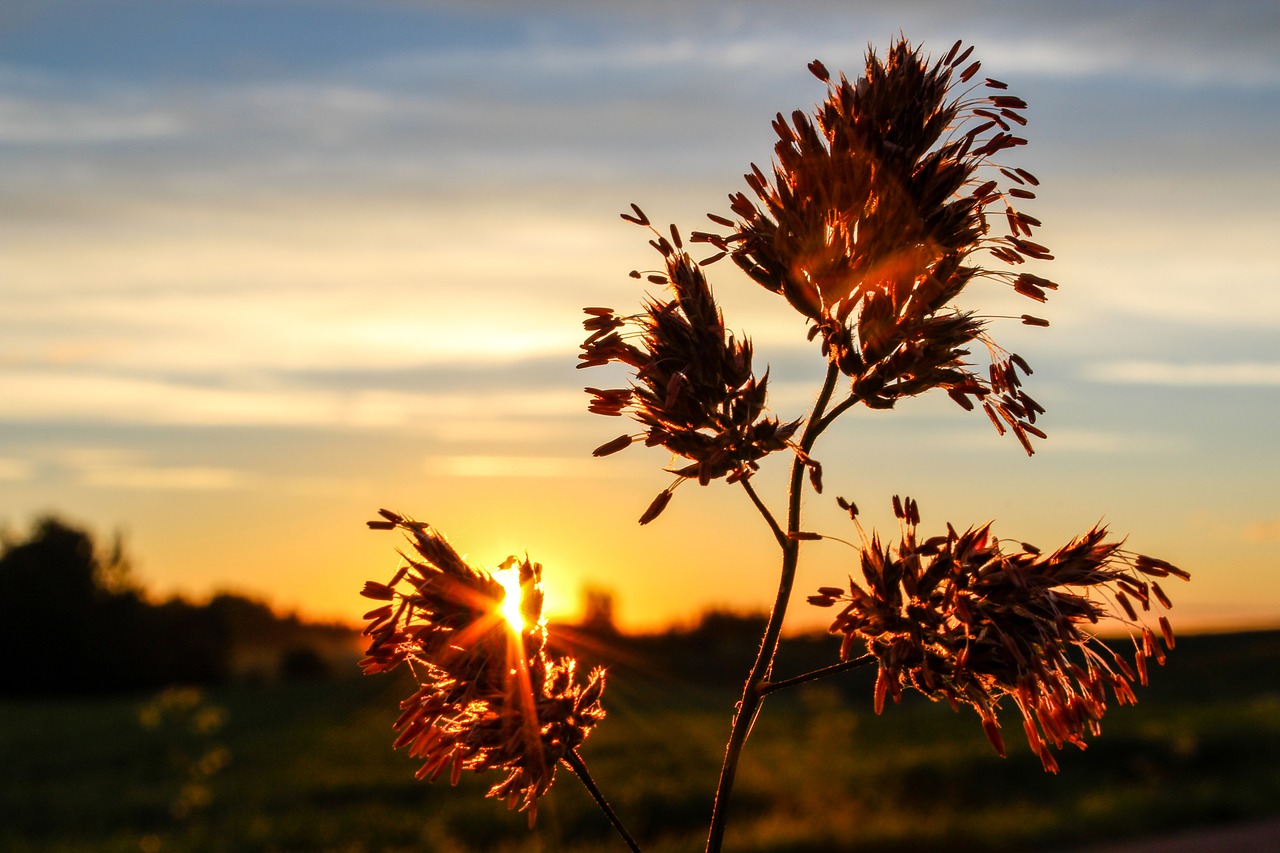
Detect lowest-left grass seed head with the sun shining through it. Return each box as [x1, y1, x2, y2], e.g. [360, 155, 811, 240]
[361, 510, 604, 822]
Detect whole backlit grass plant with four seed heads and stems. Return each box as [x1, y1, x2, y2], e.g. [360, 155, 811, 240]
[364, 38, 1188, 852]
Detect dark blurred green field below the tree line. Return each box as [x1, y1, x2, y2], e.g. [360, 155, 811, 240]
[0, 633, 1280, 853]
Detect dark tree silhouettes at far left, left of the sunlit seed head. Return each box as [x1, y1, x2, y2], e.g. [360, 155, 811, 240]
[0, 515, 351, 697]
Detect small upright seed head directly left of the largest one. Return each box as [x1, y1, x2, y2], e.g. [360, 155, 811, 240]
[577, 207, 799, 524]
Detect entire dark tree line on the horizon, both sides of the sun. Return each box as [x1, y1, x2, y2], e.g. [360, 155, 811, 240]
[0, 515, 855, 698]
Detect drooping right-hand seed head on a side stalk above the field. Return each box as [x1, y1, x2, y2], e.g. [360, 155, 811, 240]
[809, 497, 1189, 772]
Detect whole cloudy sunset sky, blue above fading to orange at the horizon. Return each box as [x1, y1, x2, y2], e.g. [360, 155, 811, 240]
[0, 0, 1280, 630]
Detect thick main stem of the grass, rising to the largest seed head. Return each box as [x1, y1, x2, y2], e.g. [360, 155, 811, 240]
[707, 362, 840, 853]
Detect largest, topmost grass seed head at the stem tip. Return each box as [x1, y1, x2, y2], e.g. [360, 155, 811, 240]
[694, 40, 1057, 452]
